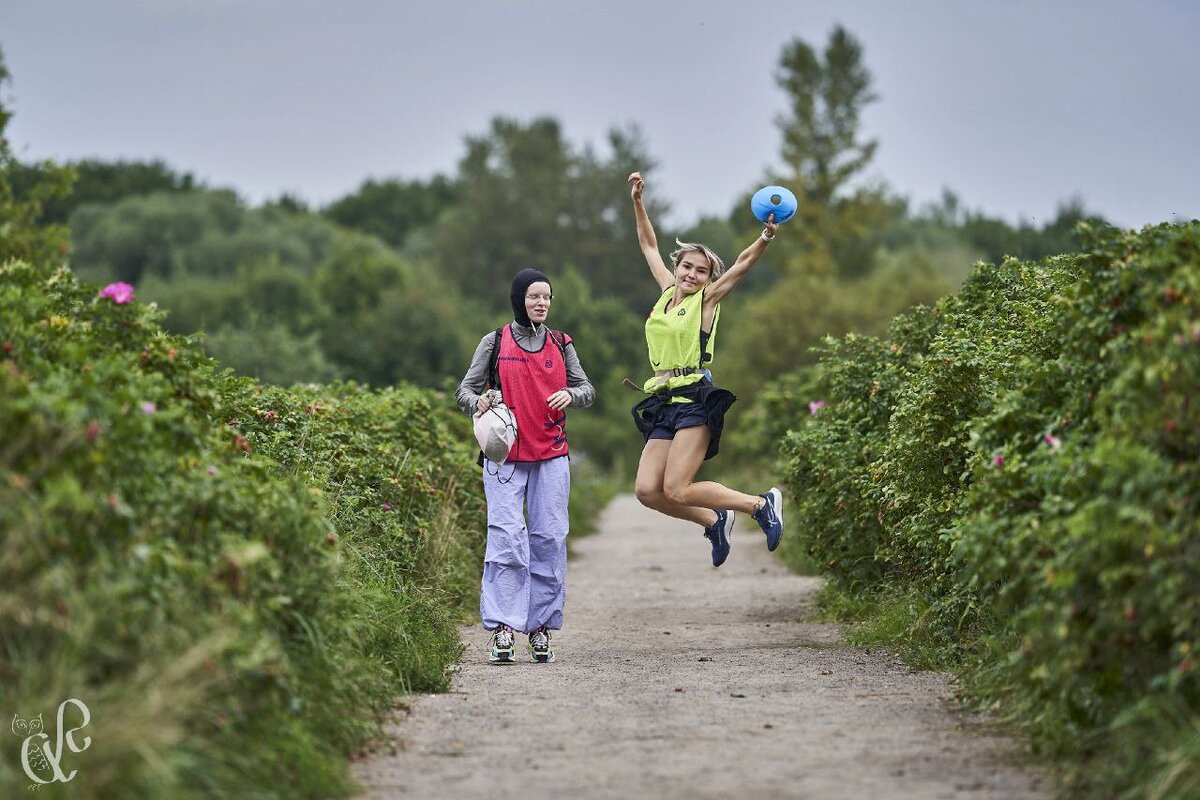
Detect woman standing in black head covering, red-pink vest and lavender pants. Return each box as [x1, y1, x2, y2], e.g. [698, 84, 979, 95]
[457, 270, 595, 663]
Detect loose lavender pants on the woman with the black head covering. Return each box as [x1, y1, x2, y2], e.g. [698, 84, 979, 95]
[479, 456, 571, 631]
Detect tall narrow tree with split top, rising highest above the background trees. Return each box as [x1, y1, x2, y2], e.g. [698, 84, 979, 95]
[775, 25, 890, 276]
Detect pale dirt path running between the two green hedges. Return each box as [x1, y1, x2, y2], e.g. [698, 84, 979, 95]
[355, 497, 1043, 800]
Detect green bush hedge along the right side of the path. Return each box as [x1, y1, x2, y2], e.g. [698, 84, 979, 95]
[775, 223, 1200, 798]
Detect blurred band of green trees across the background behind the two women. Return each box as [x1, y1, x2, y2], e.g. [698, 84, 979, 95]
[2, 28, 1091, 470]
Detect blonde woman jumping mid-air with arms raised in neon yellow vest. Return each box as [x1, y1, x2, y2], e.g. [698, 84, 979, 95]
[629, 173, 784, 566]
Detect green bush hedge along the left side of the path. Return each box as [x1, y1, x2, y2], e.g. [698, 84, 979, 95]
[0, 263, 484, 798]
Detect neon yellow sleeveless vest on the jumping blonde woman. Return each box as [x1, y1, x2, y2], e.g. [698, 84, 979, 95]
[642, 285, 721, 392]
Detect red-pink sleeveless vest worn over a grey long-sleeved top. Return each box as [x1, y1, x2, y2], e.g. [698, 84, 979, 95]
[496, 325, 571, 462]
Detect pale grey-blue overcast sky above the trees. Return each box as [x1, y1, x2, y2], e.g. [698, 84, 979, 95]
[0, 0, 1200, 227]
